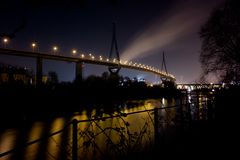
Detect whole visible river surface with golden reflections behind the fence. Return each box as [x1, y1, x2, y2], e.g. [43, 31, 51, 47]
[0, 92, 214, 160]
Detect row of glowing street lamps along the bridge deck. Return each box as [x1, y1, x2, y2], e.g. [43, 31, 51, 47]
[3, 38, 174, 78]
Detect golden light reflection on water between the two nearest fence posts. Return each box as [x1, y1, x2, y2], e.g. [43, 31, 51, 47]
[70, 100, 171, 159]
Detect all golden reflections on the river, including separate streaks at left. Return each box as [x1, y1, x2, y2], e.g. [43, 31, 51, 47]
[0, 99, 191, 160]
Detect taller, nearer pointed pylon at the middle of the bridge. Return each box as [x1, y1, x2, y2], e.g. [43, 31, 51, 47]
[108, 23, 121, 74]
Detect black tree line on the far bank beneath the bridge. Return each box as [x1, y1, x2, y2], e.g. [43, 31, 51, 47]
[0, 75, 179, 105]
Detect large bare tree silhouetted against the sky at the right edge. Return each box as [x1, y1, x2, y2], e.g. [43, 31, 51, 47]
[200, 0, 240, 83]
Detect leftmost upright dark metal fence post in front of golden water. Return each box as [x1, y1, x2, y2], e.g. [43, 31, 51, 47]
[72, 119, 78, 160]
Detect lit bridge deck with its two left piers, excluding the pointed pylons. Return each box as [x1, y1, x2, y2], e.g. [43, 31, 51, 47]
[0, 48, 175, 83]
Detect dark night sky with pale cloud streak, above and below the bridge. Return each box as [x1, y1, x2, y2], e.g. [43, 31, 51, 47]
[0, 0, 223, 83]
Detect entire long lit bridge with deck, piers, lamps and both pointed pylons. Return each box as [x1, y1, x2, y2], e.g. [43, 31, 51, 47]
[0, 23, 176, 84]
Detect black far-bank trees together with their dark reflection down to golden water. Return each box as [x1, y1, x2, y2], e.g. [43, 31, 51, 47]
[0, 74, 180, 123]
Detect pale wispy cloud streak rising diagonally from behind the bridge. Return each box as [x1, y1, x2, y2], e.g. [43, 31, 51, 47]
[121, 0, 222, 60]
